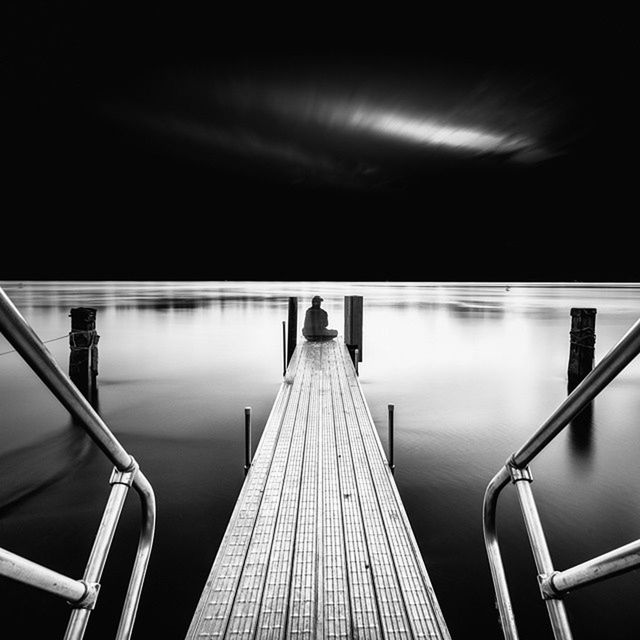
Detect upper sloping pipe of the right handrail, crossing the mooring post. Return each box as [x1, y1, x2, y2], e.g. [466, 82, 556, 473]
[512, 320, 640, 469]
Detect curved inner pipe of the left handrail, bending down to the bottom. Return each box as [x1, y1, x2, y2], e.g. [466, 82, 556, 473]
[116, 470, 156, 640]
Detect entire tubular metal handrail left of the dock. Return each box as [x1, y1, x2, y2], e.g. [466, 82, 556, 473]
[0, 287, 156, 640]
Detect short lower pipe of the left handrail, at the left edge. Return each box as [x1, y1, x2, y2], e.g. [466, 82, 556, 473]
[0, 548, 88, 602]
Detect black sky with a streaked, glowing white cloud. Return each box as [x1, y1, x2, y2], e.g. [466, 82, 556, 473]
[0, 2, 640, 281]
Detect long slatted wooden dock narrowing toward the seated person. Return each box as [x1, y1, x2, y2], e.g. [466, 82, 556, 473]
[187, 341, 450, 640]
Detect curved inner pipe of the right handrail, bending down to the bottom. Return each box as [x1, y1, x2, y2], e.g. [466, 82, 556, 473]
[482, 467, 518, 640]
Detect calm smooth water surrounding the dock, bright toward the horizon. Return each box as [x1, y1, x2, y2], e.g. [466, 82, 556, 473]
[0, 282, 640, 640]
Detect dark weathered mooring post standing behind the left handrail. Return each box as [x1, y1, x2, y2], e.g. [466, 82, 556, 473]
[69, 307, 100, 401]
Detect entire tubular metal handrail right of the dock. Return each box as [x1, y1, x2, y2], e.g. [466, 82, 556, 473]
[483, 320, 640, 640]
